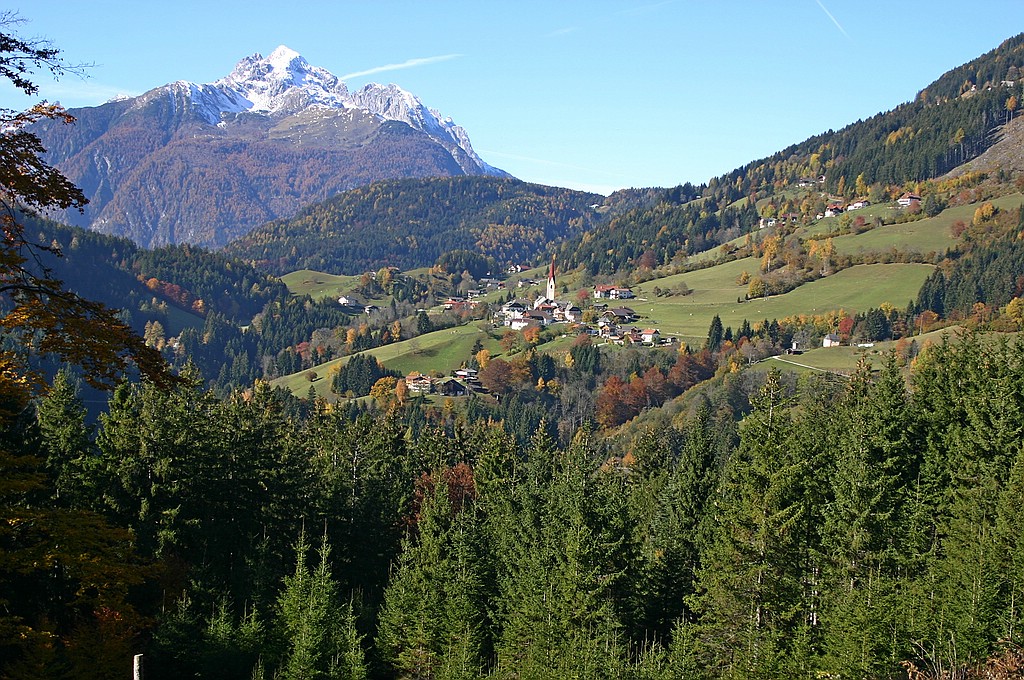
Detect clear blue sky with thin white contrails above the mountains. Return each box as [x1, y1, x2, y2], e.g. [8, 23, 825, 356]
[6, 0, 1024, 194]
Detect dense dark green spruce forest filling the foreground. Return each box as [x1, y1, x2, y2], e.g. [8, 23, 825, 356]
[0, 336, 1024, 679]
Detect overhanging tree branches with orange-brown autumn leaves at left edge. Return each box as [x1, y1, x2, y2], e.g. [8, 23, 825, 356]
[0, 17, 176, 395]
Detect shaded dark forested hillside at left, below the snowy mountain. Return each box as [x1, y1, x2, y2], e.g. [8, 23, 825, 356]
[26, 218, 364, 393]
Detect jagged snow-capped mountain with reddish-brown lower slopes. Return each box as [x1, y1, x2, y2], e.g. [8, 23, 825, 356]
[34, 46, 509, 247]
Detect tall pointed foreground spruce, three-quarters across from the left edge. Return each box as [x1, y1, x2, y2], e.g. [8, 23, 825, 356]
[694, 370, 815, 678]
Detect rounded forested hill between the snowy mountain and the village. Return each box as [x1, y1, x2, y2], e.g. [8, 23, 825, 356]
[226, 177, 602, 273]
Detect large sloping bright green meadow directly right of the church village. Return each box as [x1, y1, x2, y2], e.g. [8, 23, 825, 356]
[629, 258, 934, 345]
